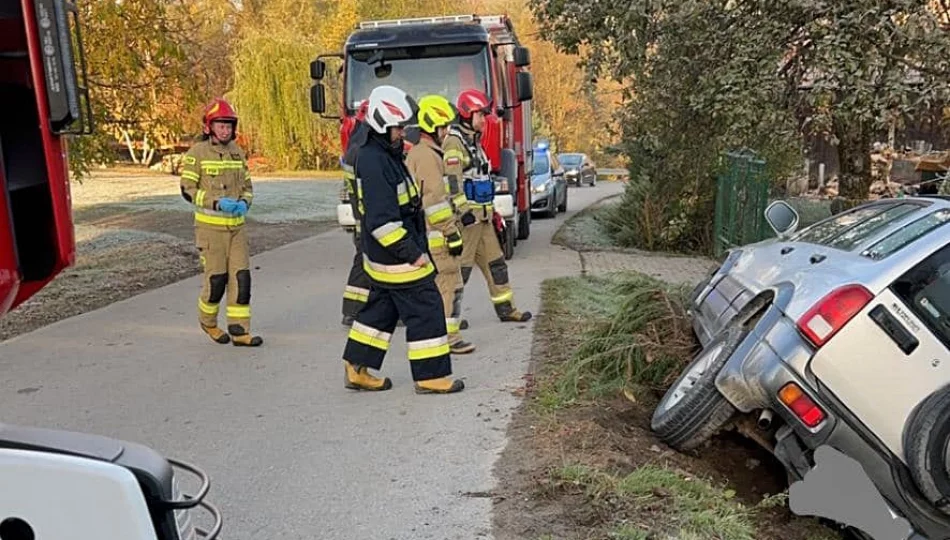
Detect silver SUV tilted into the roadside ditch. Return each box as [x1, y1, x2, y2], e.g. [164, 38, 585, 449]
[652, 197, 950, 539]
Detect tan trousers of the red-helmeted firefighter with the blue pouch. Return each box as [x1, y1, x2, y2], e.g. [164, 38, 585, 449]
[461, 221, 515, 319]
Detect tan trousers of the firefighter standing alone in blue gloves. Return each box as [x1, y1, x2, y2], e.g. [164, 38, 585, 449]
[195, 225, 251, 335]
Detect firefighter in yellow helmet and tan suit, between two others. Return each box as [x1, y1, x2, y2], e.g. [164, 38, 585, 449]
[406, 95, 475, 354]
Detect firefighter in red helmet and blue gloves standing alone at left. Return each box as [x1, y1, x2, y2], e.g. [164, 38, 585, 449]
[181, 99, 264, 347]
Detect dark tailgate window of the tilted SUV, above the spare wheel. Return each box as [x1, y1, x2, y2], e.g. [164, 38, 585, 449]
[891, 240, 950, 347]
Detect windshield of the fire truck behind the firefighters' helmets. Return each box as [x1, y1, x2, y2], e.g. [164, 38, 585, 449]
[346, 43, 492, 112]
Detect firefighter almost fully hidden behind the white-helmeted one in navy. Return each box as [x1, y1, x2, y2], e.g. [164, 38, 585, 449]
[342, 100, 370, 326]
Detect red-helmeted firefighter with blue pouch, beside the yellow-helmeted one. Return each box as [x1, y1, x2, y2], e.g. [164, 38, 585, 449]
[443, 90, 531, 322]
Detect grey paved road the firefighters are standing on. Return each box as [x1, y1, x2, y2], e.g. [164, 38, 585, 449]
[0, 183, 621, 540]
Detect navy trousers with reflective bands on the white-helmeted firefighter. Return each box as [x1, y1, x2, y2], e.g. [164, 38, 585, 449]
[343, 279, 452, 381]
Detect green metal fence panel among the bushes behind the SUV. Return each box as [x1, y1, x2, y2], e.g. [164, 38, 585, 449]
[713, 149, 772, 257]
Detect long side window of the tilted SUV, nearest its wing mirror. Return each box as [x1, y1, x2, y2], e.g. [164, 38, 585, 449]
[794, 201, 921, 251]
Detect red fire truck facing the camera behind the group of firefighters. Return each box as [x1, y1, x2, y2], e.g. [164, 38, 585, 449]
[310, 15, 533, 259]
